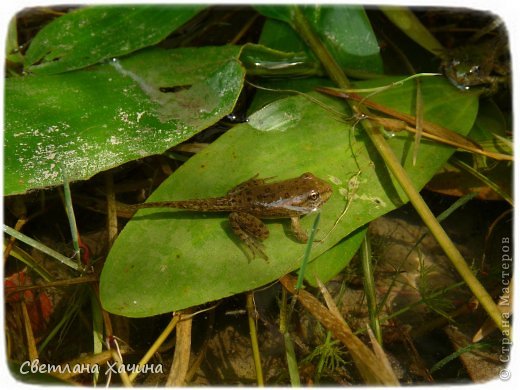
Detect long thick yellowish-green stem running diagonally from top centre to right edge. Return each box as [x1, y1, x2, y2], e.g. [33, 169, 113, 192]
[293, 7, 509, 330]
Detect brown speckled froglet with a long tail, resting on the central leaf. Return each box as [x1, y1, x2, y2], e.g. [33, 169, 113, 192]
[130, 172, 332, 261]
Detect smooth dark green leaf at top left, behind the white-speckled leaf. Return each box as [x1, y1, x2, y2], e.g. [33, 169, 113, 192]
[25, 5, 203, 74]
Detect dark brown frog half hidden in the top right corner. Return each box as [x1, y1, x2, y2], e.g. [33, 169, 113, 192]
[441, 39, 509, 95]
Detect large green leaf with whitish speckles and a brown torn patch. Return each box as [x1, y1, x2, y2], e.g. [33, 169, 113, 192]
[4, 46, 245, 195]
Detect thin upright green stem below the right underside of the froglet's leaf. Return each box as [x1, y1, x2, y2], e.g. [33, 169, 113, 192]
[361, 236, 383, 345]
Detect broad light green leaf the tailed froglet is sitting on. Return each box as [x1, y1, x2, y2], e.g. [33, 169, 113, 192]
[100, 79, 478, 317]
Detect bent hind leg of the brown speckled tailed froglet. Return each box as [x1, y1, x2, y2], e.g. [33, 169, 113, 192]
[229, 212, 269, 261]
